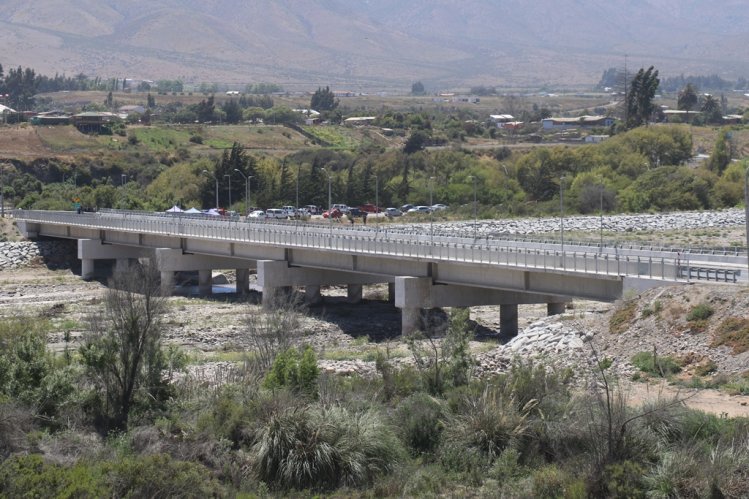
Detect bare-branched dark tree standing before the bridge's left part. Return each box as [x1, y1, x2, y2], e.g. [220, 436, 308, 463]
[80, 264, 171, 430]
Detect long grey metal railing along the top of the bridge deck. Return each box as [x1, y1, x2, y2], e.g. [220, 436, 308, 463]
[14, 210, 737, 282]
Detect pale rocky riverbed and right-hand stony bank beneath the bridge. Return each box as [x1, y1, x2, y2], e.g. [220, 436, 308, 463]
[0, 215, 749, 416]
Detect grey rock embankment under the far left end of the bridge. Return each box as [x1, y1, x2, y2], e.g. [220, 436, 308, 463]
[0, 240, 76, 270]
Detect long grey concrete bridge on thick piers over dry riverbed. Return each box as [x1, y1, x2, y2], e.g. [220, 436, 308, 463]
[14, 210, 746, 335]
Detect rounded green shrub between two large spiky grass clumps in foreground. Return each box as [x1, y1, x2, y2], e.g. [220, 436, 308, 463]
[393, 393, 445, 455]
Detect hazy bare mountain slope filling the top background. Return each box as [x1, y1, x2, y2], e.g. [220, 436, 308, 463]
[0, 0, 749, 91]
